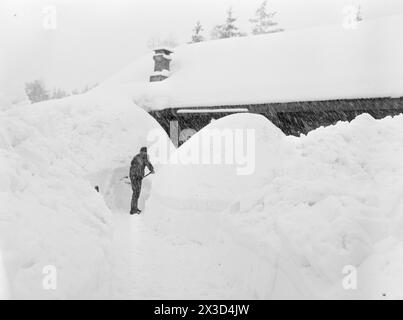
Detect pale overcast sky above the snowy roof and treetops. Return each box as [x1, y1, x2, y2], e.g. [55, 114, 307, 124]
[0, 0, 403, 97]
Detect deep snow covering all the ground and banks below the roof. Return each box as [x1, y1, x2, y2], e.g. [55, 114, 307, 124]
[0, 89, 403, 298]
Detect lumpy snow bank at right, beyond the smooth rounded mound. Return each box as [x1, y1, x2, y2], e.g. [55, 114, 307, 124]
[226, 115, 403, 298]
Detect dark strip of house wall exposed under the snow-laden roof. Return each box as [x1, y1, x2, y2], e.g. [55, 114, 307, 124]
[150, 97, 403, 143]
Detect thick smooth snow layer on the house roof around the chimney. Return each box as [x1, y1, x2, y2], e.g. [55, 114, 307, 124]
[100, 15, 403, 109]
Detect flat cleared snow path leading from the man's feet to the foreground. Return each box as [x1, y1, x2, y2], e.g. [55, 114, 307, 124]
[106, 213, 229, 299]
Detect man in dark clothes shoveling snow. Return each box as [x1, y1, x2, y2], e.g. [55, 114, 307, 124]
[129, 147, 154, 214]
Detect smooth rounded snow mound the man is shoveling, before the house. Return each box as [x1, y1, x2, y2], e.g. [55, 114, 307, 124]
[150, 113, 284, 211]
